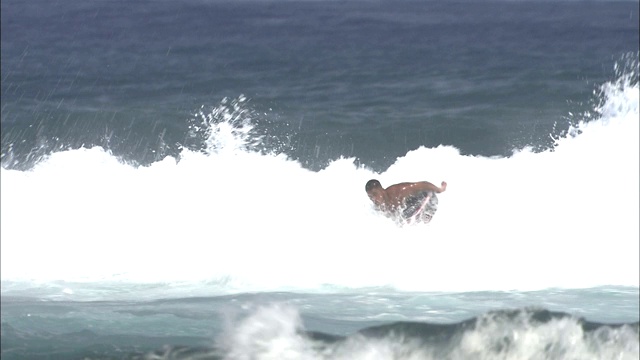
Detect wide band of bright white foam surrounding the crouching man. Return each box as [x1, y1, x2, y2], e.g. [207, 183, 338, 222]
[0, 71, 640, 293]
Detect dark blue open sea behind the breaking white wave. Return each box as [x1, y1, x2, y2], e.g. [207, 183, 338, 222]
[2, 0, 638, 169]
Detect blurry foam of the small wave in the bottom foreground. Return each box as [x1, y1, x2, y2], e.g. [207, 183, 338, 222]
[218, 305, 639, 360]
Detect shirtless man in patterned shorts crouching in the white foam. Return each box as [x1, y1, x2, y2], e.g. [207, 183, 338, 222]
[365, 180, 447, 223]
